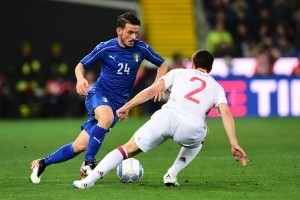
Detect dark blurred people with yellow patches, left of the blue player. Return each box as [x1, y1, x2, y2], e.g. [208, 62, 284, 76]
[0, 41, 89, 118]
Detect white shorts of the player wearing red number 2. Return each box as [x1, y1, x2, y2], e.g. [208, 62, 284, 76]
[134, 108, 207, 152]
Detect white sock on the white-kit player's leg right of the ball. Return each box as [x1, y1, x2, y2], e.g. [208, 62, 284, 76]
[168, 144, 202, 177]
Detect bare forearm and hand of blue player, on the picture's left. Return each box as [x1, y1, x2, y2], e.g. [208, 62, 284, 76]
[75, 63, 89, 96]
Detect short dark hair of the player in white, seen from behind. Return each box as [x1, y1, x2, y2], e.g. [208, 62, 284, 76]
[192, 50, 215, 73]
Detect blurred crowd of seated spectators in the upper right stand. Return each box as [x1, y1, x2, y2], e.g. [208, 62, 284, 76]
[204, 0, 300, 75]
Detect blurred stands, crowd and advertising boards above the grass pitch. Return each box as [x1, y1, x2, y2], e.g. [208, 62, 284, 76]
[0, 0, 300, 119]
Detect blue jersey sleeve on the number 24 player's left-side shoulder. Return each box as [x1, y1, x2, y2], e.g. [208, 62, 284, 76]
[80, 43, 103, 69]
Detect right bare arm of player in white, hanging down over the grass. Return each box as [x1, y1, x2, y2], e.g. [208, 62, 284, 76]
[219, 103, 249, 166]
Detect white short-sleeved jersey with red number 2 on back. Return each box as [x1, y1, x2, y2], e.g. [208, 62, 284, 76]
[162, 69, 227, 124]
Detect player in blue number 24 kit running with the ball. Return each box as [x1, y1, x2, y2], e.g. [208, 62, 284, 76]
[30, 12, 168, 184]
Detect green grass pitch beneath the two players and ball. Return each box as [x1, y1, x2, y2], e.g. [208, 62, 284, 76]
[0, 118, 300, 200]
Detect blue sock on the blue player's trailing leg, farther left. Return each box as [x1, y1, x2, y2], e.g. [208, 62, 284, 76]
[45, 143, 77, 166]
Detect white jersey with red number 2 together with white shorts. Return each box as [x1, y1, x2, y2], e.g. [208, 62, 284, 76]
[135, 69, 227, 152]
